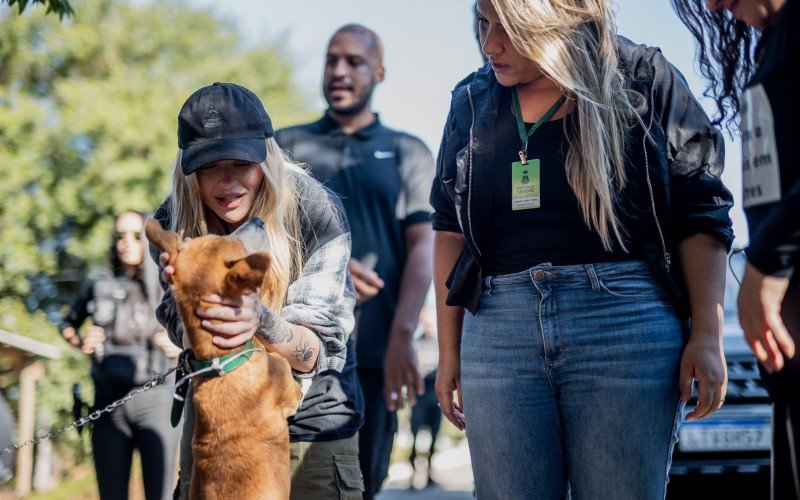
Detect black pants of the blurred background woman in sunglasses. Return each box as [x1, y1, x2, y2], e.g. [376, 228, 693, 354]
[92, 387, 180, 500]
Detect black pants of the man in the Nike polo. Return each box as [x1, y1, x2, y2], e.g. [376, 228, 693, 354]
[358, 367, 397, 500]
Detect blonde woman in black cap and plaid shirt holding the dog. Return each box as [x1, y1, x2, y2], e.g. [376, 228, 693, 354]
[151, 83, 364, 499]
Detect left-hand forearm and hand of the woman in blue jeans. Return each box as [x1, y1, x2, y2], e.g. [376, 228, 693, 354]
[433, 231, 466, 430]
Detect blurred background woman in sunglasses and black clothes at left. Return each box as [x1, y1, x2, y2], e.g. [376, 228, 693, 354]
[61, 212, 180, 500]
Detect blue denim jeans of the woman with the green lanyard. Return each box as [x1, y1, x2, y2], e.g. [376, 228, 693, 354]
[461, 261, 684, 500]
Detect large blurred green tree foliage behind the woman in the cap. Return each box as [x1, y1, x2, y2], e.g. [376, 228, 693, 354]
[0, 0, 309, 464]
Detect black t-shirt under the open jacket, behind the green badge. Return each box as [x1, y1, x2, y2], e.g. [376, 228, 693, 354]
[481, 85, 635, 275]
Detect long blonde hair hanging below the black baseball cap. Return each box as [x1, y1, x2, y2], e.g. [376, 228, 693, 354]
[170, 138, 306, 311]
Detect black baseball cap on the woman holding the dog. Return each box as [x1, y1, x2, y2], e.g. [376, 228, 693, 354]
[178, 82, 275, 175]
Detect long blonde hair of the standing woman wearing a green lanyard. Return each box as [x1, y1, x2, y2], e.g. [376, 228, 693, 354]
[491, 0, 644, 250]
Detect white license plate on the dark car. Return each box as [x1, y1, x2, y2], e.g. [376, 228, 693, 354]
[678, 419, 772, 451]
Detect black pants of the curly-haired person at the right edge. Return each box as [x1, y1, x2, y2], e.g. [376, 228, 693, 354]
[761, 278, 800, 500]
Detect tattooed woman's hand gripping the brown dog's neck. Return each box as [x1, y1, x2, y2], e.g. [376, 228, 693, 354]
[195, 293, 261, 349]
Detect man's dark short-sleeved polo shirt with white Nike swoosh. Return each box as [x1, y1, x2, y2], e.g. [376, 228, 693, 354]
[275, 114, 435, 368]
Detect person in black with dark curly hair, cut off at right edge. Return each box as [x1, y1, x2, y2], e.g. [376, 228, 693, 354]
[673, 0, 800, 498]
